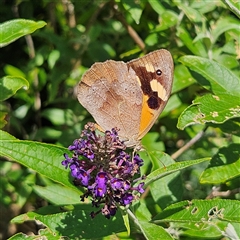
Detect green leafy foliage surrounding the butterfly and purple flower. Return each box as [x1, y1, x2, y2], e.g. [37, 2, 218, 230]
[0, 0, 240, 239]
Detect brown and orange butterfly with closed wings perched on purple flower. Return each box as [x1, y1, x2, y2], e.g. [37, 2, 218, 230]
[77, 49, 174, 147]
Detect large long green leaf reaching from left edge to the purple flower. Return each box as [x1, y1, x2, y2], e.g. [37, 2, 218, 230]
[0, 140, 79, 191]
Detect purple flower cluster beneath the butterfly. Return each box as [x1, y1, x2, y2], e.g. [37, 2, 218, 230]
[62, 123, 144, 218]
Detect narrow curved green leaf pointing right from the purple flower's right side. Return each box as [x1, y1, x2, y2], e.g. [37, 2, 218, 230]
[145, 155, 211, 187]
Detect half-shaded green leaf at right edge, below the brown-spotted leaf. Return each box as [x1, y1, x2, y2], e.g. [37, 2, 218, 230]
[200, 144, 240, 184]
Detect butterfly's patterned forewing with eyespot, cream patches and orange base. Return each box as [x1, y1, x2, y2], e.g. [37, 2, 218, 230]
[127, 49, 174, 139]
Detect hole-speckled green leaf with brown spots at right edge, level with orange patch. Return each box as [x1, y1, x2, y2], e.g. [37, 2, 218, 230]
[177, 93, 240, 129]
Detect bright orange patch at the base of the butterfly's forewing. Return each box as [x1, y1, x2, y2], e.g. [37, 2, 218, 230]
[139, 95, 154, 136]
